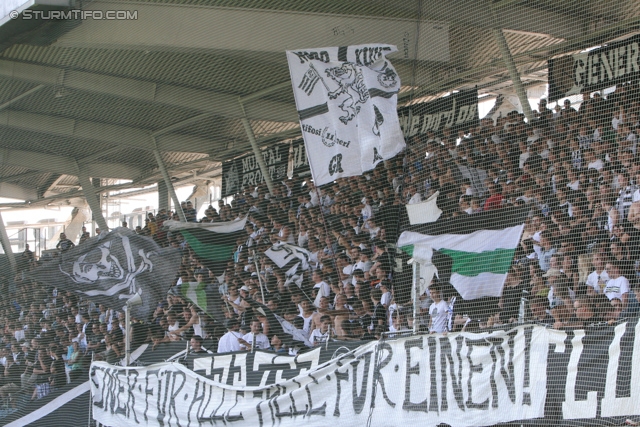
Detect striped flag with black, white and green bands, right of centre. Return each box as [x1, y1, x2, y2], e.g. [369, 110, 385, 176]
[398, 209, 524, 300]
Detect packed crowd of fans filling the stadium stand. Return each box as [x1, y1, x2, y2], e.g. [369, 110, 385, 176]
[0, 83, 640, 408]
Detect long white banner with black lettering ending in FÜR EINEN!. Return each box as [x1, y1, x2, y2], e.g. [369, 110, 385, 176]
[90, 326, 549, 427]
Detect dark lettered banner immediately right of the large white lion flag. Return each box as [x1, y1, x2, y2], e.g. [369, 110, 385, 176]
[398, 89, 479, 138]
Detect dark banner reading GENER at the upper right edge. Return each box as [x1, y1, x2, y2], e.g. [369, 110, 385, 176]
[549, 35, 640, 101]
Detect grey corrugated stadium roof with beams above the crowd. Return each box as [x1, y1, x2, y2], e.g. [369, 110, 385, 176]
[0, 0, 640, 206]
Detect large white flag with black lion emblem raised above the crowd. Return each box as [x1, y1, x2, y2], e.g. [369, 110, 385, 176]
[287, 44, 405, 185]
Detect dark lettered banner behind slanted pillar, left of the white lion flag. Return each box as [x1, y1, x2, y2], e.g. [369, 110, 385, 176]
[222, 144, 289, 197]
